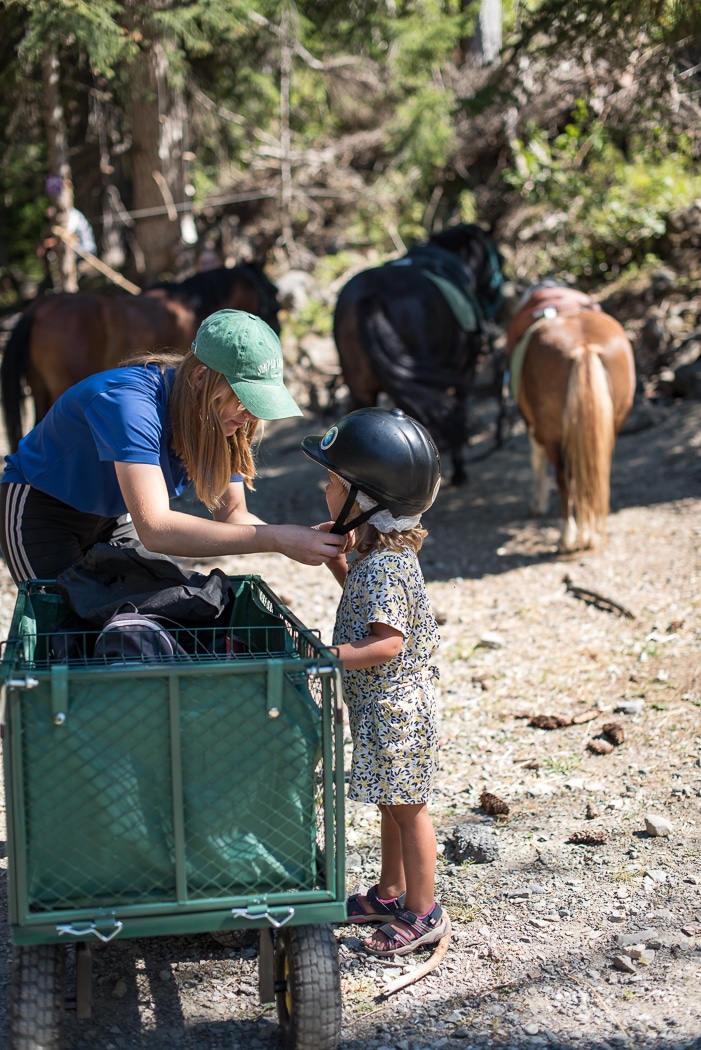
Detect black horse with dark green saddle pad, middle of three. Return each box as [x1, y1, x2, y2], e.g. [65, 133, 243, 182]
[334, 224, 503, 484]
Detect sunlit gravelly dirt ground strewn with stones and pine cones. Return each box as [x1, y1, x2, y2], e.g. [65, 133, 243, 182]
[0, 388, 701, 1050]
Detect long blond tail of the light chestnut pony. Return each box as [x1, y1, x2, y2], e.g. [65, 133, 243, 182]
[562, 345, 615, 537]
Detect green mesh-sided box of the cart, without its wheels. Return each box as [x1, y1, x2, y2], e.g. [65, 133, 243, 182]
[0, 576, 344, 923]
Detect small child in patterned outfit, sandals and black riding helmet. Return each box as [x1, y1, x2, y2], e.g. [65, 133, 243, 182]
[302, 408, 447, 956]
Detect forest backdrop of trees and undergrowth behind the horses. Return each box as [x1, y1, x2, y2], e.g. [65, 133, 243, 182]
[0, 0, 701, 390]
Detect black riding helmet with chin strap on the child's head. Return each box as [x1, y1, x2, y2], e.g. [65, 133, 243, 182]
[302, 408, 441, 532]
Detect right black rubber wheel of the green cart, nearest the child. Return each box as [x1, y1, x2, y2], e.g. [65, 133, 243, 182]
[275, 926, 341, 1050]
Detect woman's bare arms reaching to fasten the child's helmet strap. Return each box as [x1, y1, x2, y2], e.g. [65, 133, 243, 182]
[114, 463, 345, 565]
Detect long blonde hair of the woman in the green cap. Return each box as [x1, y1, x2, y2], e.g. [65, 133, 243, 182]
[123, 351, 262, 510]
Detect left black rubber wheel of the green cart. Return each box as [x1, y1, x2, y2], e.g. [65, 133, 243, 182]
[9, 944, 66, 1050]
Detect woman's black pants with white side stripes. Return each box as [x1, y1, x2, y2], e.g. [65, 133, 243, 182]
[0, 482, 136, 584]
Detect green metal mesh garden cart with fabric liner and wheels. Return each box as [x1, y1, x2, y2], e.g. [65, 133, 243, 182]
[0, 575, 345, 1050]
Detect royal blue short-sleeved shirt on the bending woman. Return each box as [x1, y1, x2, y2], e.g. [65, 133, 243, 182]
[2, 364, 199, 518]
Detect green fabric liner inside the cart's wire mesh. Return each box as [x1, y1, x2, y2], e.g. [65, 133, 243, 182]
[10, 582, 321, 911]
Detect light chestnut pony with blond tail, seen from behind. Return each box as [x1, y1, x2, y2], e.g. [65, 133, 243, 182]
[507, 287, 636, 552]
